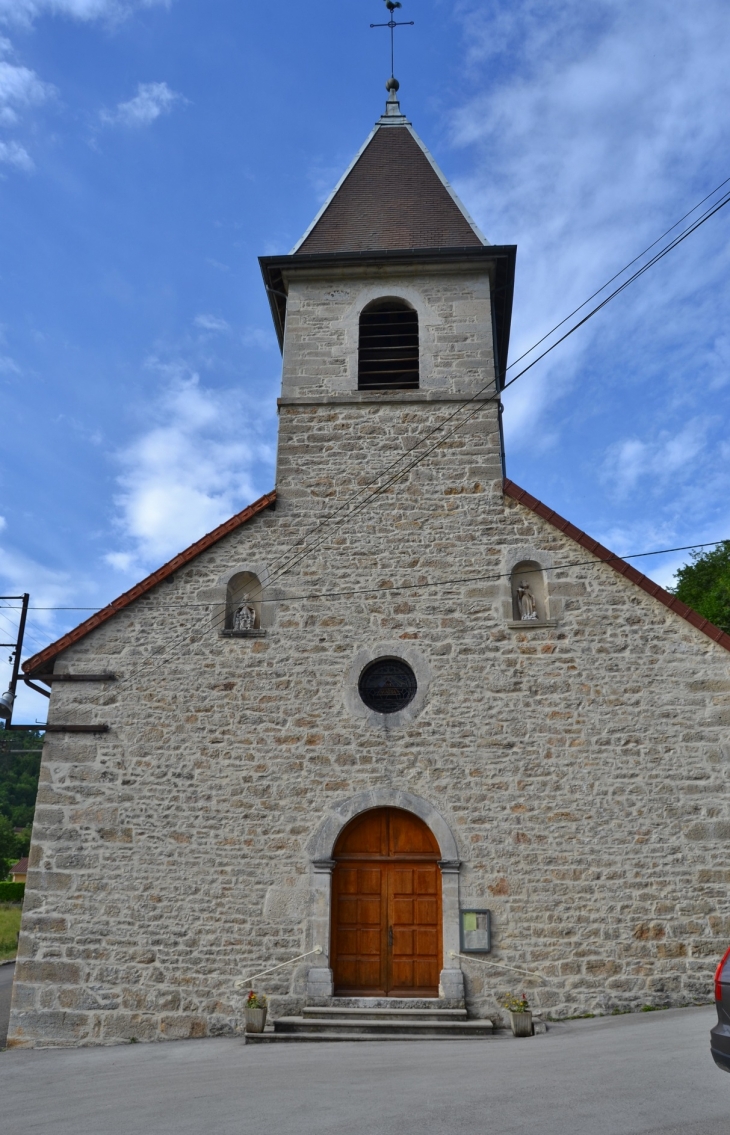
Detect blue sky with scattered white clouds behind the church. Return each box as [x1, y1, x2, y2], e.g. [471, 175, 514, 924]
[0, 0, 730, 721]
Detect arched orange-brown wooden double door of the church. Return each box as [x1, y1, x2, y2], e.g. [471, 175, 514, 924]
[330, 808, 442, 997]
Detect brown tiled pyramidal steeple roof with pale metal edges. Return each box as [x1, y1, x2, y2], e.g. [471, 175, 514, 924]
[292, 78, 489, 254]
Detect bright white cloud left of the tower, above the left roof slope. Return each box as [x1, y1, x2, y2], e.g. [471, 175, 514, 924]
[106, 363, 272, 572]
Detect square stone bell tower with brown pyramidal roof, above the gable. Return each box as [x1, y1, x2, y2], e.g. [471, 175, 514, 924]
[260, 78, 515, 531]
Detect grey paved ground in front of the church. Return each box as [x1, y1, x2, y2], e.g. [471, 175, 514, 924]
[0, 1008, 730, 1135]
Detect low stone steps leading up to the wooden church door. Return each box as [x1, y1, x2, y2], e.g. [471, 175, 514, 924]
[246, 999, 494, 1044]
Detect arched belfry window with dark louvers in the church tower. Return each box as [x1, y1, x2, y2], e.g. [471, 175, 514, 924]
[358, 300, 418, 390]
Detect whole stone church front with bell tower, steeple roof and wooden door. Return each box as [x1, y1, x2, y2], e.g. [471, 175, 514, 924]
[8, 86, 730, 1046]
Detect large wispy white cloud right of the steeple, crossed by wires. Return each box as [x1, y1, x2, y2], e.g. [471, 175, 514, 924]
[453, 0, 730, 445]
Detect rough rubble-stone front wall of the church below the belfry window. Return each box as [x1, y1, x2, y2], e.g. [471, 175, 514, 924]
[9, 265, 730, 1045]
